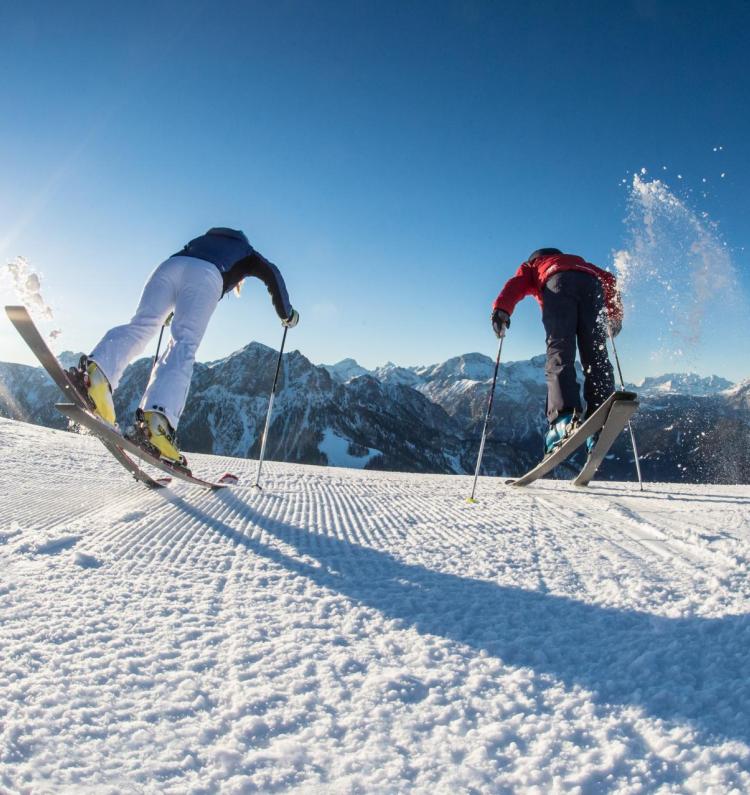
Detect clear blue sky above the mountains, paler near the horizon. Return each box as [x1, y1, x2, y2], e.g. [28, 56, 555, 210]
[0, 0, 750, 379]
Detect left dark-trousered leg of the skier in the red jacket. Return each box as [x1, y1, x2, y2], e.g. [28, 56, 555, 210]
[542, 271, 581, 423]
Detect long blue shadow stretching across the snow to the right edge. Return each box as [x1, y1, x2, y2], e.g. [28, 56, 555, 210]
[160, 491, 750, 743]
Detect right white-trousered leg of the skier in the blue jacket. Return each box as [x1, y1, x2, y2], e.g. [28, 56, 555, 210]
[141, 257, 223, 429]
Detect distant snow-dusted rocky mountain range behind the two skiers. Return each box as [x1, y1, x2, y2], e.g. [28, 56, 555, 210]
[0, 343, 750, 483]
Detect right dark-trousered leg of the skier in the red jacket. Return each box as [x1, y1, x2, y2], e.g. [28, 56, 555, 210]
[577, 276, 615, 417]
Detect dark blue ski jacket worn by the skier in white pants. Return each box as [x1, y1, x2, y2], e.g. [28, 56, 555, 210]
[172, 226, 292, 320]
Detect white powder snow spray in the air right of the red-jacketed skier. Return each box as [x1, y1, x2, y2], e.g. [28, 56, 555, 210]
[614, 175, 750, 482]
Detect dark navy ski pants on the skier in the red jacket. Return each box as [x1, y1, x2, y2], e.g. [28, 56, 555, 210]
[542, 271, 615, 422]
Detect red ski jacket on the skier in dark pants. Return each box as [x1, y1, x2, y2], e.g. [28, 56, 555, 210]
[492, 254, 622, 323]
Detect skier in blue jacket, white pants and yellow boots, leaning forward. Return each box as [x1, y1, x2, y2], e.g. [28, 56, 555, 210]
[81, 227, 299, 463]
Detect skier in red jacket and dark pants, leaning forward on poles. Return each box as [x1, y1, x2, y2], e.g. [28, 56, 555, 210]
[492, 248, 623, 453]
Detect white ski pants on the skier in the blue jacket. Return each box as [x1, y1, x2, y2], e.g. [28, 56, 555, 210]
[90, 257, 224, 428]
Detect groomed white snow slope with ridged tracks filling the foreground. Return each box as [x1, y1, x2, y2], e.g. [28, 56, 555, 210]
[0, 420, 750, 795]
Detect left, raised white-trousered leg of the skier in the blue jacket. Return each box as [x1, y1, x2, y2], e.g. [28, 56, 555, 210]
[89, 258, 176, 390]
